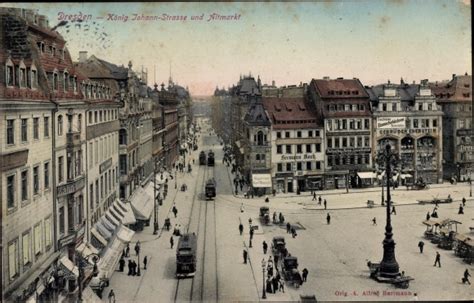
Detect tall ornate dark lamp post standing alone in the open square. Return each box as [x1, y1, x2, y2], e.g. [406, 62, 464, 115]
[379, 144, 400, 278]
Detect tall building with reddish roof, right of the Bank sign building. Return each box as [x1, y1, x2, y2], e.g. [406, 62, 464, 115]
[308, 77, 372, 188]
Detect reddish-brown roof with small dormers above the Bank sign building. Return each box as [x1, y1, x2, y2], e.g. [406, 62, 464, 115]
[262, 97, 320, 129]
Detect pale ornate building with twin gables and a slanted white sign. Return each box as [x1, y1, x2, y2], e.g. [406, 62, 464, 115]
[367, 80, 443, 184]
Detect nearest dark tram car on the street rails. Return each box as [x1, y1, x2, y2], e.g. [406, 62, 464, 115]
[176, 233, 197, 278]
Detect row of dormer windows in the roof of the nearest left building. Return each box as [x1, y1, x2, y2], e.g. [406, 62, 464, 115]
[5, 60, 38, 89]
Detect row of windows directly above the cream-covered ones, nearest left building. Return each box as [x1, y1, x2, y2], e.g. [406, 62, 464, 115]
[6, 162, 51, 210]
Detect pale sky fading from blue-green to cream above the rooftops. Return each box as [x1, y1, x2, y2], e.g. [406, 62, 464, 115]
[2, 0, 472, 95]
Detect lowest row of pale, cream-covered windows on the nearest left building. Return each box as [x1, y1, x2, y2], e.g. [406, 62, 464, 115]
[8, 216, 52, 281]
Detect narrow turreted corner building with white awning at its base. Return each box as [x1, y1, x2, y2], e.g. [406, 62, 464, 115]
[242, 96, 272, 195]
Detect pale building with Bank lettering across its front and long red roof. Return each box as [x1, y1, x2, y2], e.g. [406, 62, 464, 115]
[263, 97, 325, 193]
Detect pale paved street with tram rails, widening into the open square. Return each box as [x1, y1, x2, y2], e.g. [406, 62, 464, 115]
[104, 122, 474, 302]
